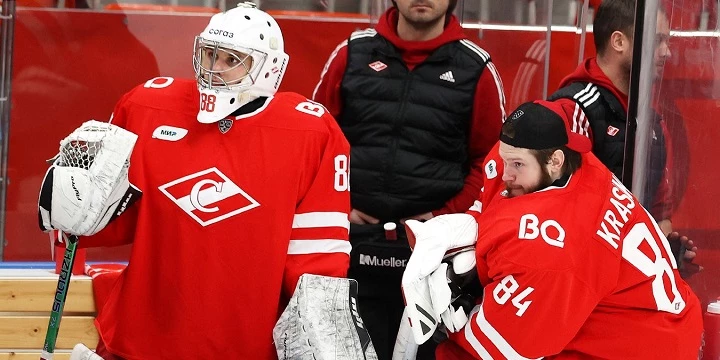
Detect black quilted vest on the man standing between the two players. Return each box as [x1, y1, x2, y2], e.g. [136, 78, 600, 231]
[338, 29, 486, 221]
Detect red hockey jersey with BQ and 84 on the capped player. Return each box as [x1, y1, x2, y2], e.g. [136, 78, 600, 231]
[437, 149, 702, 360]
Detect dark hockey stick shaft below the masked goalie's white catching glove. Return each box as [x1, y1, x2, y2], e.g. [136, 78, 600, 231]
[40, 231, 78, 360]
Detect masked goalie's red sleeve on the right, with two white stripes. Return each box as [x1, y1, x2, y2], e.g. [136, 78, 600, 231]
[283, 110, 350, 298]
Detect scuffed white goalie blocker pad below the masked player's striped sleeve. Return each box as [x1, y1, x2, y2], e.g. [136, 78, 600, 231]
[273, 274, 377, 360]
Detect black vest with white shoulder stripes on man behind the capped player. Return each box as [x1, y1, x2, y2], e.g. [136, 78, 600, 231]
[549, 82, 667, 214]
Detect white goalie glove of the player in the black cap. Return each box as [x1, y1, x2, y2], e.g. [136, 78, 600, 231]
[402, 214, 478, 344]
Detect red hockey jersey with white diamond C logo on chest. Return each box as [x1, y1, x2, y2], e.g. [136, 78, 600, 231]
[80, 78, 350, 360]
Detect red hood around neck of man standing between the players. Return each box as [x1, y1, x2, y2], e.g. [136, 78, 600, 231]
[375, 7, 466, 55]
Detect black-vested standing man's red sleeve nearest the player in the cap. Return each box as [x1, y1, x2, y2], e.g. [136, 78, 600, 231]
[433, 62, 506, 216]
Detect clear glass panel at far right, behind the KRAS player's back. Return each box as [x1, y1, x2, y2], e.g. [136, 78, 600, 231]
[633, 0, 720, 306]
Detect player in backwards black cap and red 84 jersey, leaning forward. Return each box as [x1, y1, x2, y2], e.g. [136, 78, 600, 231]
[403, 100, 702, 359]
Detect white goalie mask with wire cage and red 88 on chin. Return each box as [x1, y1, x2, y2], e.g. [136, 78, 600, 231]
[193, 2, 289, 123]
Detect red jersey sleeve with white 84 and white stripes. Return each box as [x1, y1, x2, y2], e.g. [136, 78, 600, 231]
[450, 265, 600, 359]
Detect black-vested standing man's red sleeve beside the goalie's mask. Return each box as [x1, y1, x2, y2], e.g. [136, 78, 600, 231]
[313, 40, 347, 117]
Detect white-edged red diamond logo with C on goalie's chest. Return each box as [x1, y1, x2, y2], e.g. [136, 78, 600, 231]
[158, 167, 260, 226]
